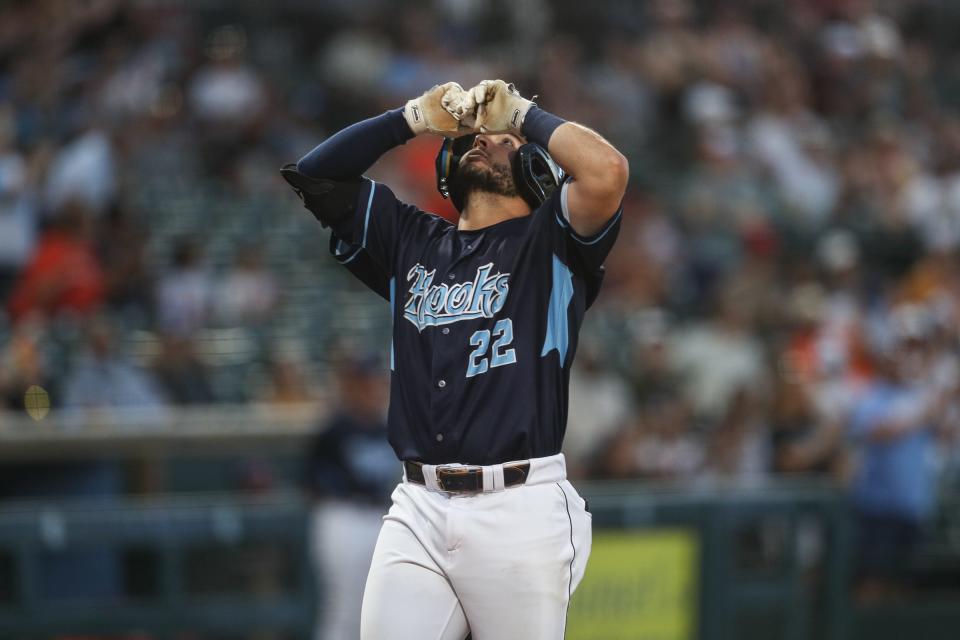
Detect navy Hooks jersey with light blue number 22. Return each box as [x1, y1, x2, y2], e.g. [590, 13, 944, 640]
[331, 179, 621, 464]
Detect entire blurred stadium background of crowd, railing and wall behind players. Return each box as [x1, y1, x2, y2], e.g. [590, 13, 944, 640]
[0, 0, 960, 640]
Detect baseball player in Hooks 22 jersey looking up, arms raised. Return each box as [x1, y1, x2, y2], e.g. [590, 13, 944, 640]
[282, 80, 628, 640]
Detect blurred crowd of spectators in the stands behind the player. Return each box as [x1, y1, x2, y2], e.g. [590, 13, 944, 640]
[0, 0, 960, 592]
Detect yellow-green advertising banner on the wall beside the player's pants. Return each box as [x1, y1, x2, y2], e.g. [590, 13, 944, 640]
[567, 529, 699, 640]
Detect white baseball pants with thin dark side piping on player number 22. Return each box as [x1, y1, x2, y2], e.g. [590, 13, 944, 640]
[360, 454, 591, 640]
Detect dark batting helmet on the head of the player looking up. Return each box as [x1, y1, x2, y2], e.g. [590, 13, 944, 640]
[437, 135, 563, 211]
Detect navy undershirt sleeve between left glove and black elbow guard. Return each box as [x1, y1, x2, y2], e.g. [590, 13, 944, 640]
[297, 107, 413, 180]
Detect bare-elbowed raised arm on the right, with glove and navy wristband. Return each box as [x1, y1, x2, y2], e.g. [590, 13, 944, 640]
[463, 80, 630, 236]
